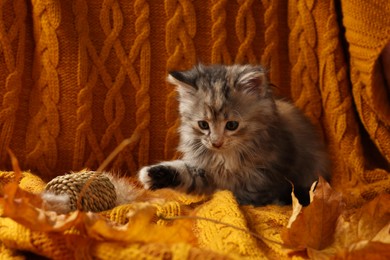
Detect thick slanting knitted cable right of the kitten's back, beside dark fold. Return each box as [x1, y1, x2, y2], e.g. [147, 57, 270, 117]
[319, 0, 364, 203]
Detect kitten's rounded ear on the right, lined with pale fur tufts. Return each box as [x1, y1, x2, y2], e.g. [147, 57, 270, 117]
[236, 66, 270, 97]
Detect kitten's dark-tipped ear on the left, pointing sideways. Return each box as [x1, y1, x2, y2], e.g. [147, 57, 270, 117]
[167, 71, 196, 96]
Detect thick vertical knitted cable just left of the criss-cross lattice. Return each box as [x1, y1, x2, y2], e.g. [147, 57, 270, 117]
[26, 0, 61, 175]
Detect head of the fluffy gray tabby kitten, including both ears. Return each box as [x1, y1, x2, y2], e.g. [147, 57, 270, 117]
[168, 65, 274, 152]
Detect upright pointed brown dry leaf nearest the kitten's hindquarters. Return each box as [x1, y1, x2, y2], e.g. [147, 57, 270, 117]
[281, 177, 344, 250]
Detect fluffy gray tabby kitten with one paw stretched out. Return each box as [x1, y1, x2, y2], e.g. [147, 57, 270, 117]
[139, 64, 329, 206]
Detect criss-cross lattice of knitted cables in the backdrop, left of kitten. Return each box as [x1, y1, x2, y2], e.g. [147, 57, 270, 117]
[74, 1, 150, 172]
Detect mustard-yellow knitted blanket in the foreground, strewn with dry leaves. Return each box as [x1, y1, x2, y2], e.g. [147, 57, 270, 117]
[0, 170, 390, 259]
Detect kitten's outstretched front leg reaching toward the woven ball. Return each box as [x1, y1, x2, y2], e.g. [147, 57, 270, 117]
[138, 160, 215, 194]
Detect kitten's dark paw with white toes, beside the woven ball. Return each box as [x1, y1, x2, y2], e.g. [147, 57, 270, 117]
[138, 165, 180, 190]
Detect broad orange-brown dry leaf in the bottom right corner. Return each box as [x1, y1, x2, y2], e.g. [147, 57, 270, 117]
[298, 190, 390, 259]
